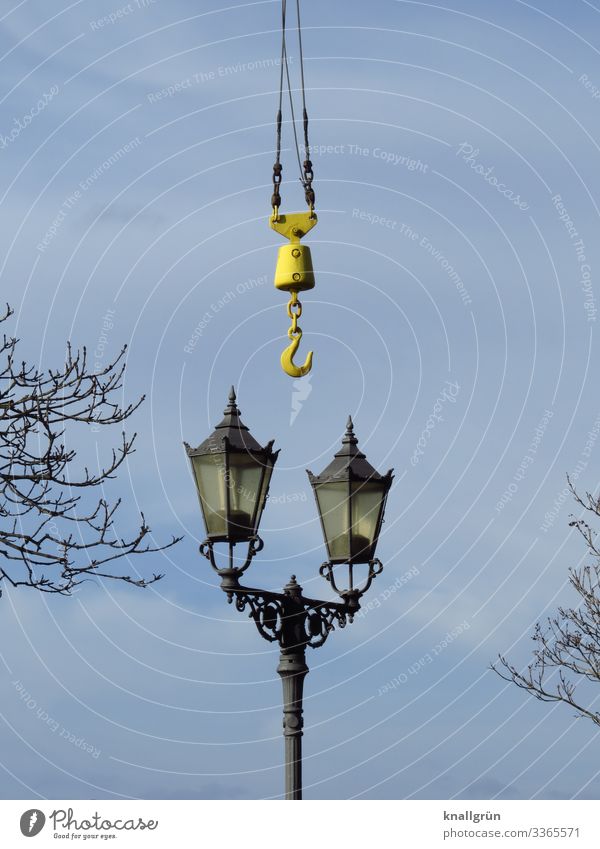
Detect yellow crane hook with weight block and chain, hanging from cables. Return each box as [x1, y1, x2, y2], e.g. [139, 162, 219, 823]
[270, 209, 317, 377]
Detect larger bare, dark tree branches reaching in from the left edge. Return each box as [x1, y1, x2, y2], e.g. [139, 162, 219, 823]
[0, 307, 178, 595]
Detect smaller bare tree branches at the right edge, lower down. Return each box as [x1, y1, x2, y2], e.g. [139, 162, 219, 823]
[492, 480, 600, 725]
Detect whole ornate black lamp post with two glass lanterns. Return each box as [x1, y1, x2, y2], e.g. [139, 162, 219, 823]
[184, 387, 393, 799]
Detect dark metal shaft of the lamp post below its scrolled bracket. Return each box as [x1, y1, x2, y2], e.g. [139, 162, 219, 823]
[277, 646, 308, 799]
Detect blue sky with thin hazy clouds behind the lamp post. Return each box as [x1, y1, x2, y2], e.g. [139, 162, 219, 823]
[0, 0, 600, 800]
